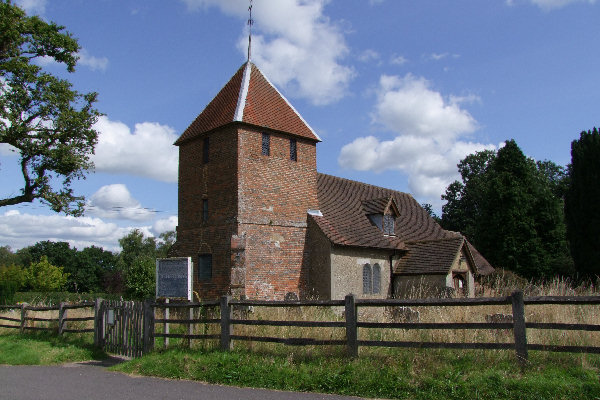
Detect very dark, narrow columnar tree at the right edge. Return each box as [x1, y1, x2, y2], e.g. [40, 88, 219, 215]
[565, 128, 600, 277]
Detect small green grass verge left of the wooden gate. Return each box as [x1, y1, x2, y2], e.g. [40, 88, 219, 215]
[0, 332, 108, 365]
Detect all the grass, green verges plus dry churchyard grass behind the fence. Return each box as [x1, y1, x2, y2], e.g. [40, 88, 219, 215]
[0, 275, 600, 400]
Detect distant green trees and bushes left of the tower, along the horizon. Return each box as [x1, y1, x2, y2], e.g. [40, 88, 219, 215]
[0, 229, 175, 299]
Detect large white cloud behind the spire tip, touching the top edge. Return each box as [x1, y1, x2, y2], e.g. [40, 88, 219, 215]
[183, 0, 355, 105]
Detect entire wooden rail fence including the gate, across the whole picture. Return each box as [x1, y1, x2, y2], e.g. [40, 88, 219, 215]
[0, 291, 600, 363]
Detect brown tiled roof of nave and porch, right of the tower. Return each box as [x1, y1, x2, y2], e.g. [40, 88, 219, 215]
[310, 173, 493, 275]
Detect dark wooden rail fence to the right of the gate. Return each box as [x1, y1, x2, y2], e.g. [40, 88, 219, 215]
[149, 291, 600, 362]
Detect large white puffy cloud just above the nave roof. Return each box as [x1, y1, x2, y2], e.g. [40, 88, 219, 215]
[338, 74, 496, 205]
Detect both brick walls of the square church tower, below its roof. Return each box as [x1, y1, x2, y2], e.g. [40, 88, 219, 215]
[173, 124, 318, 299]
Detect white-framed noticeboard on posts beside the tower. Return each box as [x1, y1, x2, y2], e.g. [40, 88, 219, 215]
[156, 257, 192, 301]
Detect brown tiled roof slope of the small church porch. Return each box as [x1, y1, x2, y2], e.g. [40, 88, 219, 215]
[394, 235, 465, 275]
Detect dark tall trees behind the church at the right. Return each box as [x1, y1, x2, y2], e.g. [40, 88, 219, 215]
[439, 128, 600, 279]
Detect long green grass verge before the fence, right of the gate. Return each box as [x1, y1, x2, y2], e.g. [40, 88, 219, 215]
[113, 348, 600, 400]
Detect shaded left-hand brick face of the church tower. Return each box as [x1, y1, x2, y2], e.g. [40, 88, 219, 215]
[173, 125, 237, 299]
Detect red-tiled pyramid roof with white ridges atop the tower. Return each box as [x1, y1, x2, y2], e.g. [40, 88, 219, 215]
[175, 62, 321, 145]
